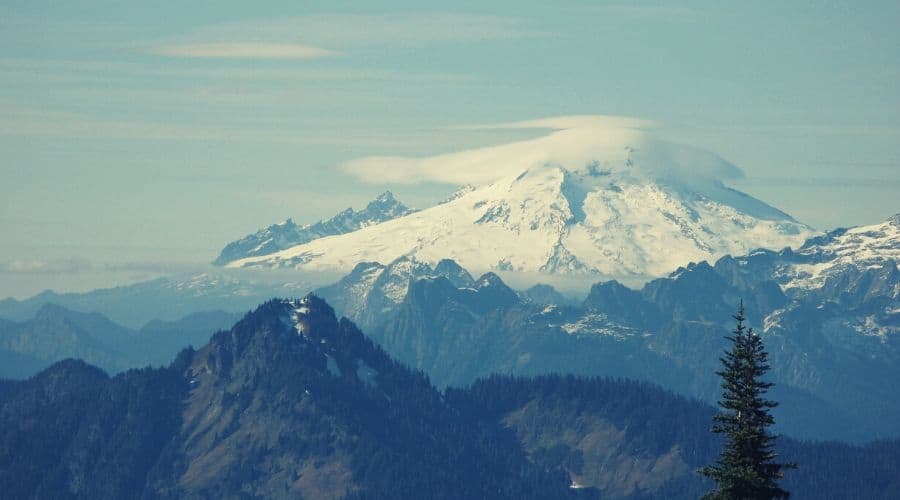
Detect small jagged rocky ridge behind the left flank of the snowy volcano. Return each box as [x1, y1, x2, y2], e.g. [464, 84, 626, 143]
[213, 191, 413, 266]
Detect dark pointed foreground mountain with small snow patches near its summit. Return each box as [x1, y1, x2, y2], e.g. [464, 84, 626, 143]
[0, 297, 576, 499]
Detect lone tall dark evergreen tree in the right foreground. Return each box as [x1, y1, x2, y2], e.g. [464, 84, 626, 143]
[700, 301, 796, 500]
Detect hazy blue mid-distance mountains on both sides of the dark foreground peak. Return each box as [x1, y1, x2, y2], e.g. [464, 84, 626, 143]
[0, 216, 900, 442]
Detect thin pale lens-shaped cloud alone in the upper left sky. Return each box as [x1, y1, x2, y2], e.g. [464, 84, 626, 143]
[150, 42, 338, 59]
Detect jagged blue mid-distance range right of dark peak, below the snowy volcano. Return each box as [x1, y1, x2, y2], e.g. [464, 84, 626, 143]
[317, 213, 900, 440]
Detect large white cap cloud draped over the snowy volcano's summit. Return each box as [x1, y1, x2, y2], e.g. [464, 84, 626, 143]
[341, 115, 742, 188]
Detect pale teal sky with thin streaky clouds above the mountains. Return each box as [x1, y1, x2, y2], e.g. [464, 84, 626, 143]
[0, 0, 900, 298]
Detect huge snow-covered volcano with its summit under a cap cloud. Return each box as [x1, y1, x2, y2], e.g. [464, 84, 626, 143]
[228, 122, 815, 283]
